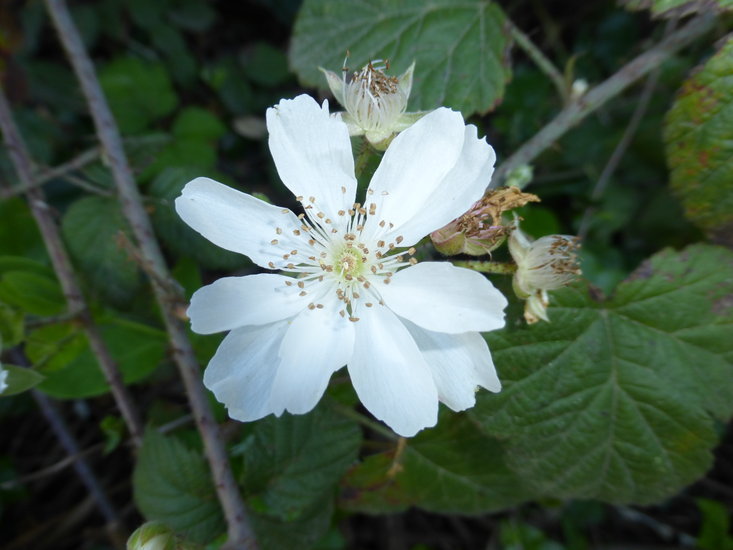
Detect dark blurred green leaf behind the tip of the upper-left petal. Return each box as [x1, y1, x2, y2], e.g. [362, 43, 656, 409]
[149, 167, 249, 271]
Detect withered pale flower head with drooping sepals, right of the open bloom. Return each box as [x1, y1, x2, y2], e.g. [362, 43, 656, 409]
[509, 223, 580, 324]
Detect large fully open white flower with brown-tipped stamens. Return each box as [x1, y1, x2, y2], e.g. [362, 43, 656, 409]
[176, 95, 507, 436]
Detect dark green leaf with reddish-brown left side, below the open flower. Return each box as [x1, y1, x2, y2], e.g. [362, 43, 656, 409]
[340, 413, 532, 514]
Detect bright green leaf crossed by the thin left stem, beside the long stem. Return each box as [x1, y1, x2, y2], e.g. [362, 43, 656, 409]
[33, 316, 167, 399]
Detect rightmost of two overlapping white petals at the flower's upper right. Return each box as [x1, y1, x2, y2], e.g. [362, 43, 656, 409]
[382, 125, 496, 246]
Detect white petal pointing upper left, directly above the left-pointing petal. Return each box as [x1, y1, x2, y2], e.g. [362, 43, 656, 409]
[176, 178, 308, 269]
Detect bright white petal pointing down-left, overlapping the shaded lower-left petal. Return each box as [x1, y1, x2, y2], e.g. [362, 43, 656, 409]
[270, 294, 354, 414]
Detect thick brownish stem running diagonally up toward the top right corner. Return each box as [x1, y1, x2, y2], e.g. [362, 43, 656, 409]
[489, 14, 715, 189]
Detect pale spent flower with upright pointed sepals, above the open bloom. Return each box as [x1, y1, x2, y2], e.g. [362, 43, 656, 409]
[321, 60, 425, 149]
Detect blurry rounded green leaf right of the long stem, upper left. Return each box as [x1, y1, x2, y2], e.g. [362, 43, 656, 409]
[99, 57, 178, 134]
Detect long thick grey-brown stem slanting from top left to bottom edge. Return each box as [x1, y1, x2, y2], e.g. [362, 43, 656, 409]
[46, 0, 257, 549]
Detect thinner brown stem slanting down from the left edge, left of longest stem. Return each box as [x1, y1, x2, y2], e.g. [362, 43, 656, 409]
[0, 89, 143, 445]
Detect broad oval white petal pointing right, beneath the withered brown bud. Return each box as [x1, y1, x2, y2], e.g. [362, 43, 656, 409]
[374, 262, 507, 334]
